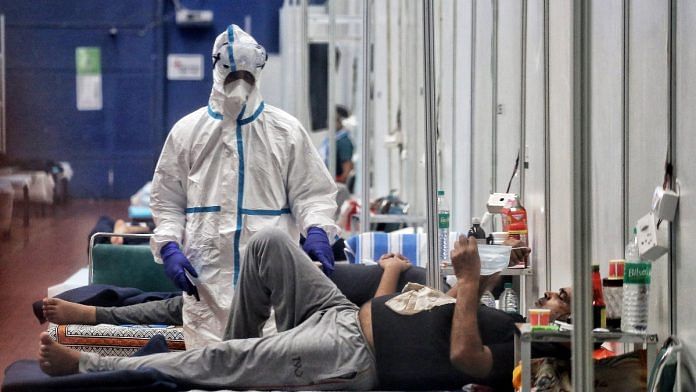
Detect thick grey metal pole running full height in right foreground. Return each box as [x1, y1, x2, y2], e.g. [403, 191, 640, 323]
[572, 0, 594, 392]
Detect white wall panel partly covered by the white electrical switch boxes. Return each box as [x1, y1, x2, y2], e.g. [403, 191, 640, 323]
[628, 0, 670, 338]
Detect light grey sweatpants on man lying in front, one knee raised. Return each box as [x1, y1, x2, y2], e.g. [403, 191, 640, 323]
[80, 229, 377, 390]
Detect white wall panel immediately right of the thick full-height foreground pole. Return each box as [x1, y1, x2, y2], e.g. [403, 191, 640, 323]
[591, 0, 624, 276]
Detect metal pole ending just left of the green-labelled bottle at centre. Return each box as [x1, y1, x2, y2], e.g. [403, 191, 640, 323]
[423, 0, 442, 288]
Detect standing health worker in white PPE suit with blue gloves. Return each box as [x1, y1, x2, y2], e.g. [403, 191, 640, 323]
[150, 25, 339, 348]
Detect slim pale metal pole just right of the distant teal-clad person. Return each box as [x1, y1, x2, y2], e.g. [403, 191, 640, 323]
[360, 0, 372, 233]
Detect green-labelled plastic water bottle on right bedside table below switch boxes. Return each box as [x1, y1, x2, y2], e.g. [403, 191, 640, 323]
[621, 227, 652, 333]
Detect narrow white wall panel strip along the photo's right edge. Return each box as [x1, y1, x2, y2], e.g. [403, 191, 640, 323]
[673, 0, 696, 391]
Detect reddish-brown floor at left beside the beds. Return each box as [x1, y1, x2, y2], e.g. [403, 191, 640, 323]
[0, 199, 129, 382]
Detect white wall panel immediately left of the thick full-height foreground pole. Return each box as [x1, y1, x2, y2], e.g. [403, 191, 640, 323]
[547, 0, 573, 289]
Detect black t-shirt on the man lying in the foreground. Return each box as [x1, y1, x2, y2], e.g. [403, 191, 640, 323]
[372, 294, 522, 391]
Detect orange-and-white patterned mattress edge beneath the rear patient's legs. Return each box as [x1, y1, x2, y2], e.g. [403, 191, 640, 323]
[48, 324, 186, 357]
